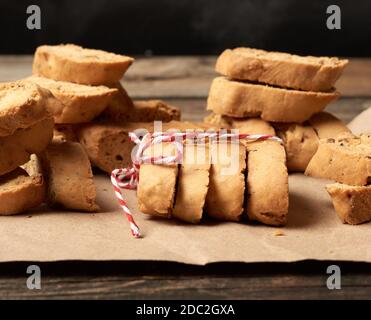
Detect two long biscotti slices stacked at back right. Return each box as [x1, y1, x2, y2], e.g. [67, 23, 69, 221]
[207, 48, 348, 123]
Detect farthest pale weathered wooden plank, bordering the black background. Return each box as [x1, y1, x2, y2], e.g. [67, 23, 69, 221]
[0, 56, 371, 98]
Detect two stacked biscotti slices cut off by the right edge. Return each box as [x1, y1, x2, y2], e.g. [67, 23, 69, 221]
[305, 133, 371, 224]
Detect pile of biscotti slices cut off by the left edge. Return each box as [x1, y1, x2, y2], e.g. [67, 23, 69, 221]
[0, 81, 59, 215]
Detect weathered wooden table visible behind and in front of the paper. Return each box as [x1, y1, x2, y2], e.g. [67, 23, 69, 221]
[0, 56, 371, 299]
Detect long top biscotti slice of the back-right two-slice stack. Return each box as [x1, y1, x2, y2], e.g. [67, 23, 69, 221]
[216, 48, 348, 91]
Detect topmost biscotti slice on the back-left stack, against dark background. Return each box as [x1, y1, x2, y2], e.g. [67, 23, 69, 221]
[32, 44, 134, 85]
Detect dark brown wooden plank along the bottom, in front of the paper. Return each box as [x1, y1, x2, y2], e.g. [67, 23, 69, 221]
[0, 274, 371, 300]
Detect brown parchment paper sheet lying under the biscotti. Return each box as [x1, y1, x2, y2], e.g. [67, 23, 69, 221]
[0, 109, 371, 265]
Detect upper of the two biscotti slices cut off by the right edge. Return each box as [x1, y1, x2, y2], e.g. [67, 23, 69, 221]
[305, 133, 371, 186]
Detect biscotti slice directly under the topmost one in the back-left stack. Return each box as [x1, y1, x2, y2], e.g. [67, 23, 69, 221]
[26, 76, 117, 124]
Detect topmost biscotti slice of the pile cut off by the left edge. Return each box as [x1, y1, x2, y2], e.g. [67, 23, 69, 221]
[0, 81, 56, 137]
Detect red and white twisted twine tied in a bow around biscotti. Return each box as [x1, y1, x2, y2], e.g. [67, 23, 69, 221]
[111, 131, 282, 238]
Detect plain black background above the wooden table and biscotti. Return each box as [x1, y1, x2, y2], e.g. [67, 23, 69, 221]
[0, 0, 371, 56]
